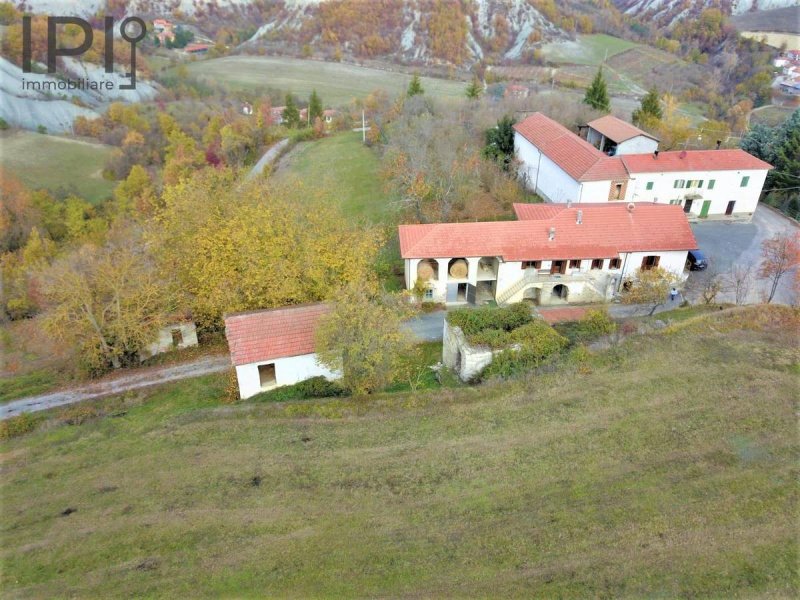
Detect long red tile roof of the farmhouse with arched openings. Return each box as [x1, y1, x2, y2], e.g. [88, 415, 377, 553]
[399, 202, 697, 261]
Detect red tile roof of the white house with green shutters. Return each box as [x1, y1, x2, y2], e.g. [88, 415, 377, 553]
[619, 148, 772, 173]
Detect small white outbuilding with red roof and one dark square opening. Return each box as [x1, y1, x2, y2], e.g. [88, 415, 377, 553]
[225, 304, 338, 400]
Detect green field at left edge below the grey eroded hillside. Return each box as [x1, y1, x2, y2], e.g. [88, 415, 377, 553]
[0, 131, 115, 202]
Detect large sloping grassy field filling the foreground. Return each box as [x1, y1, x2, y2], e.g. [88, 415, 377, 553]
[0, 307, 800, 598]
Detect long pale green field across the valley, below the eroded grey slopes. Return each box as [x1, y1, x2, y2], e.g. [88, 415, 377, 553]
[188, 56, 467, 106]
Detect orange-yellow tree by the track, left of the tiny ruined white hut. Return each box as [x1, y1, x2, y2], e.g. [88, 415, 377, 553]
[41, 227, 174, 373]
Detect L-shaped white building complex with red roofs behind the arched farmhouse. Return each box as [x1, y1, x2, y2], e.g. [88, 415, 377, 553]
[514, 113, 772, 220]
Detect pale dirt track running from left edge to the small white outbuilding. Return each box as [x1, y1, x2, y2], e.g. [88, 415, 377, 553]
[0, 354, 231, 420]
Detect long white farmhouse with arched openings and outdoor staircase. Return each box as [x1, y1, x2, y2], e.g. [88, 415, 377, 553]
[399, 202, 697, 305]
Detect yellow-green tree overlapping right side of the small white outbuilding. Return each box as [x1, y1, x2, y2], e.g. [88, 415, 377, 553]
[316, 285, 413, 396]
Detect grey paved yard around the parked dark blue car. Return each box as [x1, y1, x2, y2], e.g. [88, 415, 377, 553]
[686, 204, 800, 304]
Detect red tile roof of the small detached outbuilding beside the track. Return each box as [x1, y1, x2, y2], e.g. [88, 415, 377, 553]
[225, 304, 331, 366]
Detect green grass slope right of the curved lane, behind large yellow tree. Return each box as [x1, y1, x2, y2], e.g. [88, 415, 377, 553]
[277, 131, 396, 224]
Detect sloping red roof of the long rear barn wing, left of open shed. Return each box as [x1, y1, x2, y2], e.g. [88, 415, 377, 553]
[514, 113, 628, 181]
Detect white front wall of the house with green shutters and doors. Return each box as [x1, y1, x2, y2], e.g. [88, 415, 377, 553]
[626, 170, 767, 219]
